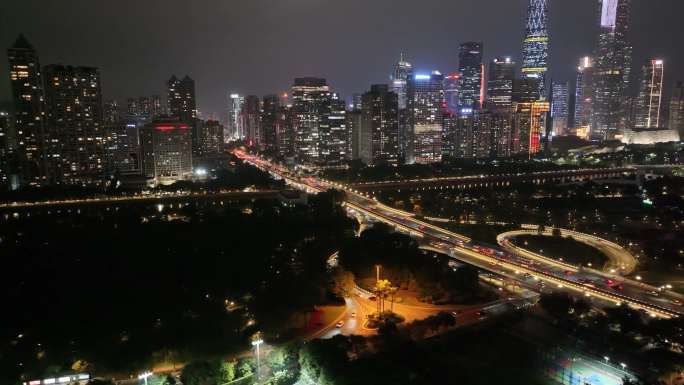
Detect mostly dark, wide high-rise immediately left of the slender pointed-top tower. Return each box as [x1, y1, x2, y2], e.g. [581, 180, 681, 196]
[359, 84, 400, 166]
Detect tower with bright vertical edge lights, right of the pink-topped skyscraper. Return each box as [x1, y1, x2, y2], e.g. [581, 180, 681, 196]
[634, 59, 665, 128]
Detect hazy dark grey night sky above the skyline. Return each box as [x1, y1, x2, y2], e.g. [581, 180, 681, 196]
[0, 0, 684, 118]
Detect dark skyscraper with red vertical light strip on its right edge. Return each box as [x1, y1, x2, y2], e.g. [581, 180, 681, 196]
[458, 42, 484, 113]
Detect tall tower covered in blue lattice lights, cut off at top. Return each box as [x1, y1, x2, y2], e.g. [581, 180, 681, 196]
[522, 0, 549, 97]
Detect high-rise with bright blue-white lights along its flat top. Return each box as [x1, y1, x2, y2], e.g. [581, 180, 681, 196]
[413, 71, 444, 164]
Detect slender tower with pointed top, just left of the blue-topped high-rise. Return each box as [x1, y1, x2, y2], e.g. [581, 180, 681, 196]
[390, 53, 415, 163]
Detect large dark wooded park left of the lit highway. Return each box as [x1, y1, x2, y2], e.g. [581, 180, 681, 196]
[0, 190, 356, 383]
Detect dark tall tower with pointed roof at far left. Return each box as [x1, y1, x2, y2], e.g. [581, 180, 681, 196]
[7, 35, 48, 185]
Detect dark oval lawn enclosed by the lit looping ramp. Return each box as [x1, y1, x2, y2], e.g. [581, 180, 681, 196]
[512, 235, 608, 269]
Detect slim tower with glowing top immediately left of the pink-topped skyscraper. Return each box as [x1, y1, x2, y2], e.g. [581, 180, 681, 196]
[573, 56, 595, 139]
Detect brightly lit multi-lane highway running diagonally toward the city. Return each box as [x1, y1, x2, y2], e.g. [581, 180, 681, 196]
[235, 151, 684, 318]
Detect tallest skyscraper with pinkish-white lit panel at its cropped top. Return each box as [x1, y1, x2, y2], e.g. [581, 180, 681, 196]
[591, 0, 632, 140]
